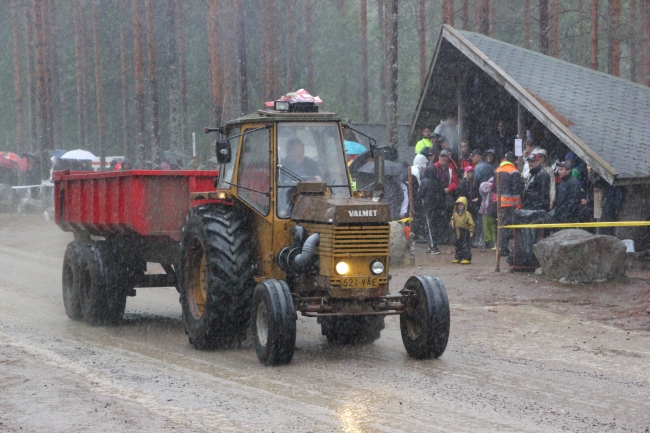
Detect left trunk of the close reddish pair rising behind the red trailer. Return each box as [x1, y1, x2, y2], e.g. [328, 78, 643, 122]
[131, 0, 146, 167]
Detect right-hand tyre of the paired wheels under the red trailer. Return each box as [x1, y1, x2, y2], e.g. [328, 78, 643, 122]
[79, 241, 126, 325]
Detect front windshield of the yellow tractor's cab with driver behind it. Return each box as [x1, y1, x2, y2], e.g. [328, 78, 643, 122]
[277, 122, 350, 218]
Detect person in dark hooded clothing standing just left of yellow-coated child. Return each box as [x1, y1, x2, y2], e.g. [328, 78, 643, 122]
[417, 166, 446, 254]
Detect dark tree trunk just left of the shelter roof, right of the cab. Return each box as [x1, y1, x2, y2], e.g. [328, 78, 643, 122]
[386, 0, 399, 148]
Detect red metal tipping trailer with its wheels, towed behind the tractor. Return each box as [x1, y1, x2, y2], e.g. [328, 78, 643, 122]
[53, 170, 221, 324]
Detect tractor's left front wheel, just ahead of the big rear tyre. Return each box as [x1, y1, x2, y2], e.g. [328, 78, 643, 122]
[251, 279, 297, 365]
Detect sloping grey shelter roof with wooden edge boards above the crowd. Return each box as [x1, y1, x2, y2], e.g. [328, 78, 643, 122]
[410, 25, 650, 184]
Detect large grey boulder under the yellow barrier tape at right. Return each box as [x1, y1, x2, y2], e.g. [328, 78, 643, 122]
[533, 229, 626, 283]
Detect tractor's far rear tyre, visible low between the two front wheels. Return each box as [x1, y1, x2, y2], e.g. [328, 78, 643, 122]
[320, 316, 385, 344]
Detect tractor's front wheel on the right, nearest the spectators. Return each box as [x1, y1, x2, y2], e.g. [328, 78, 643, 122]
[399, 275, 450, 359]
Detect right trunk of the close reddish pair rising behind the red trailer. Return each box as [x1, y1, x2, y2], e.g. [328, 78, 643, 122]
[144, 0, 160, 167]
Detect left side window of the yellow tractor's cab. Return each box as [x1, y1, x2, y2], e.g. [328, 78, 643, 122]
[237, 129, 271, 215]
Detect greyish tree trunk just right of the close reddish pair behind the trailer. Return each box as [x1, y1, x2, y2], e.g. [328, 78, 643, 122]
[166, 0, 181, 150]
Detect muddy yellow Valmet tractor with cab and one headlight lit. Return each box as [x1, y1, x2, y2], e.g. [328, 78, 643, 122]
[187, 102, 450, 365]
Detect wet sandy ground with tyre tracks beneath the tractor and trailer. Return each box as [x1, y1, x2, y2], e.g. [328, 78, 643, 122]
[0, 214, 650, 432]
